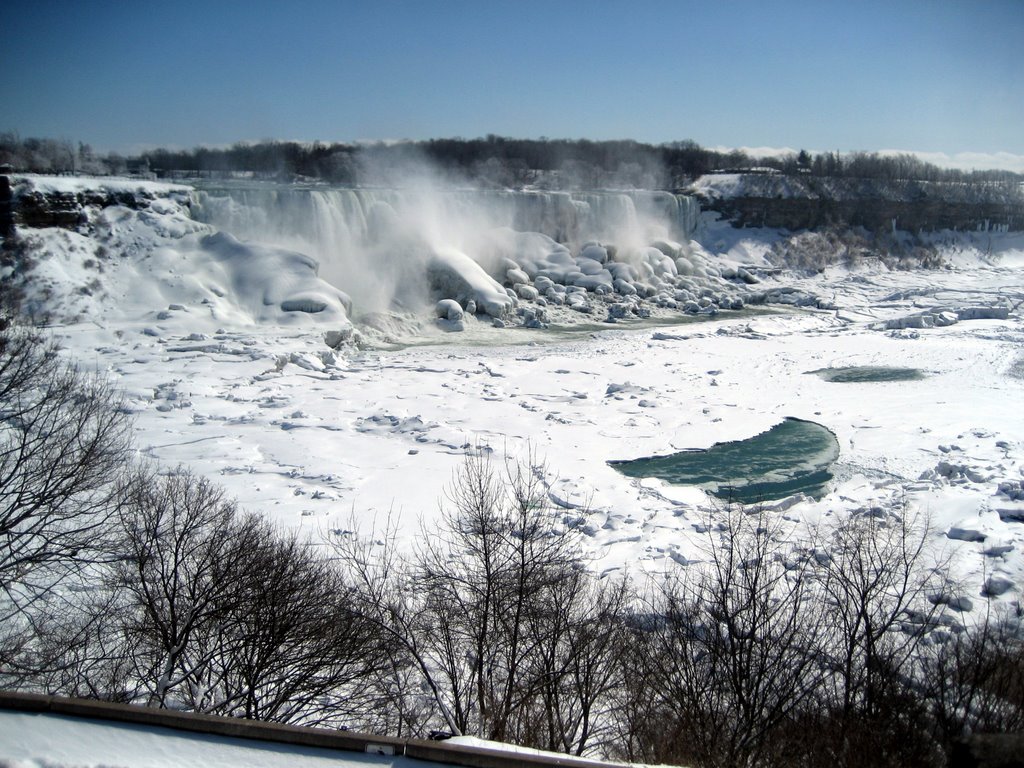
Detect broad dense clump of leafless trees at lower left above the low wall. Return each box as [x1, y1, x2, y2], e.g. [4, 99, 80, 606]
[99, 470, 388, 726]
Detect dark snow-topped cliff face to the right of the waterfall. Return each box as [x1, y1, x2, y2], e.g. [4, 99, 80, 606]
[692, 174, 1024, 231]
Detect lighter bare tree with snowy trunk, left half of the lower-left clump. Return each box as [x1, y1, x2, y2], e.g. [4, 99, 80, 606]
[111, 462, 260, 712]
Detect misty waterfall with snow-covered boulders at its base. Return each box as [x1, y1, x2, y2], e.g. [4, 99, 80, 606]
[193, 184, 736, 327]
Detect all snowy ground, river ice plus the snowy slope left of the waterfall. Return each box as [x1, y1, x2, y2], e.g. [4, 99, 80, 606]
[8, 174, 1024, 606]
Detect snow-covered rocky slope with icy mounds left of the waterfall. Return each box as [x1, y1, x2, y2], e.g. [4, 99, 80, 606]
[4, 183, 350, 336]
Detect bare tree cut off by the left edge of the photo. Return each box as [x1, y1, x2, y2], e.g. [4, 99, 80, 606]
[0, 327, 131, 671]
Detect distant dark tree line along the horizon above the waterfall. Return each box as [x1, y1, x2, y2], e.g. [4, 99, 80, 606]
[0, 133, 1024, 189]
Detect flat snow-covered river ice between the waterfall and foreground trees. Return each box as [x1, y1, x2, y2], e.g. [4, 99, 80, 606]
[58, 262, 1024, 606]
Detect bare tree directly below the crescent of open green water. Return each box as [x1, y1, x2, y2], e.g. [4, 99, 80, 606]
[637, 507, 822, 766]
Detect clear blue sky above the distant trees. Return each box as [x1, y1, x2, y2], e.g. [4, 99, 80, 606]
[0, 0, 1024, 167]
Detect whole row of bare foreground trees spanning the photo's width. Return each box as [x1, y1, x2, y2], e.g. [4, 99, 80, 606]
[0, 326, 1024, 768]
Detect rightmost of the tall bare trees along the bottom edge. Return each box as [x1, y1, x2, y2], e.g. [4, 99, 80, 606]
[816, 503, 940, 765]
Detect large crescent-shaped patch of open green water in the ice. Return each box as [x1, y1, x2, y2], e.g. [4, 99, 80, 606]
[608, 418, 839, 504]
